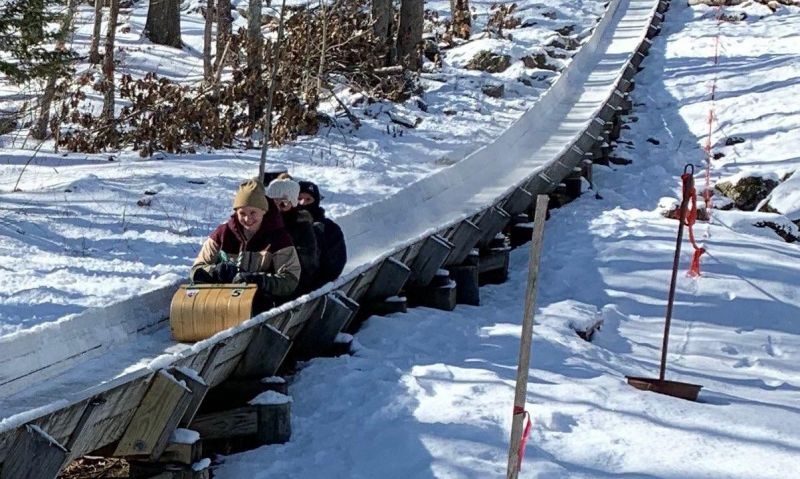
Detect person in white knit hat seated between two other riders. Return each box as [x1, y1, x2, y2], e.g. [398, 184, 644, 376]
[266, 174, 320, 296]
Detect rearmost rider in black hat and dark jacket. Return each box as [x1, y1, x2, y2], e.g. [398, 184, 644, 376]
[298, 181, 347, 287]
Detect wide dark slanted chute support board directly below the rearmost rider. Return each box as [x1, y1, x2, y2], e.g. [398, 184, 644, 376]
[292, 292, 354, 361]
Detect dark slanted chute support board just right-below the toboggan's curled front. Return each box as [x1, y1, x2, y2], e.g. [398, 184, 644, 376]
[234, 324, 292, 378]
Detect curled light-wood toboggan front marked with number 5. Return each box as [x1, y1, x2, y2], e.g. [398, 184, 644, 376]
[169, 284, 257, 343]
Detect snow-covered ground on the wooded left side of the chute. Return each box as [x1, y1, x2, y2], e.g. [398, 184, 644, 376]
[0, 0, 604, 337]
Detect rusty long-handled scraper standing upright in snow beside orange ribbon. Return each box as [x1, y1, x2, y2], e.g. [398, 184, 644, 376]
[625, 164, 703, 401]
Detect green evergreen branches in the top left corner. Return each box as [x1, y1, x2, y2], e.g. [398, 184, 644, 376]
[0, 0, 75, 84]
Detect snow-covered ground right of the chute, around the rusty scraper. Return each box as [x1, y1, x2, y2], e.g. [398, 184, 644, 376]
[215, 2, 800, 479]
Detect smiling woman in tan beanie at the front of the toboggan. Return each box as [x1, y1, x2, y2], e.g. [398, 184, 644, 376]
[190, 180, 300, 306]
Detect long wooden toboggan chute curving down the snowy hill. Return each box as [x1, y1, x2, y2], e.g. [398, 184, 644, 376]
[0, 0, 668, 479]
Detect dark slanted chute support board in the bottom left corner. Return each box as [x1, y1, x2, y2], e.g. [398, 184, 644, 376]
[0, 425, 69, 479]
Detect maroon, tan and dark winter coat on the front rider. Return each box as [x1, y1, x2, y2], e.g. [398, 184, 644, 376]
[190, 197, 301, 297]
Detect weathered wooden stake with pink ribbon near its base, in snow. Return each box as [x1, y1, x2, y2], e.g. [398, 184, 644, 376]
[506, 195, 548, 479]
